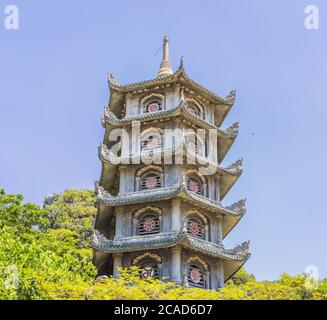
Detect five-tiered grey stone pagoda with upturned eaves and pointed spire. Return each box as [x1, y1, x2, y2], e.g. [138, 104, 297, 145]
[93, 37, 250, 289]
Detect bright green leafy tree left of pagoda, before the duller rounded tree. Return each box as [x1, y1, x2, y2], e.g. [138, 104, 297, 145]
[0, 190, 95, 299]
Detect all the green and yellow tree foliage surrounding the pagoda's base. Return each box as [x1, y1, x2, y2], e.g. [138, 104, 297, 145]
[0, 190, 327, 300]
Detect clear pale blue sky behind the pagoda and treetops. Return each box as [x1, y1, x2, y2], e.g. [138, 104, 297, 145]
[0, 0, 327, 280]
